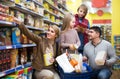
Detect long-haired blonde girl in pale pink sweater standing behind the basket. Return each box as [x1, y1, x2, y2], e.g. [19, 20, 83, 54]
[60, 13, 80, 53]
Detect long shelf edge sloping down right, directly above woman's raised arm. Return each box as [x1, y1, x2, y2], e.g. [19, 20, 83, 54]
[11, 4, 44, 18]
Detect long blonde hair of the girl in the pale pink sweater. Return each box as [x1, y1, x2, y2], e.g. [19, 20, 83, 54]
[61, 13, 74, 31]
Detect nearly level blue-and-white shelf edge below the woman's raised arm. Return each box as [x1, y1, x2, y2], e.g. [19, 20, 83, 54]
[0, 44, 36, 50]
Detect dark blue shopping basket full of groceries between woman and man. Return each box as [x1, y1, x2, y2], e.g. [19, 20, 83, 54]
[57, 62, 97, 79]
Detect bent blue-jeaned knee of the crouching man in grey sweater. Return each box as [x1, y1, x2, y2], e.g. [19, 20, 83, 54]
[94, 68, 112, 79]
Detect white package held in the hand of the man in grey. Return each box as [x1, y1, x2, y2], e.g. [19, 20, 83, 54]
[95, 51, 107, 65]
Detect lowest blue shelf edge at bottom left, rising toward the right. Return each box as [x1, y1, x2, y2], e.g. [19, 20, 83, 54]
[0, 62, 31, 77]
